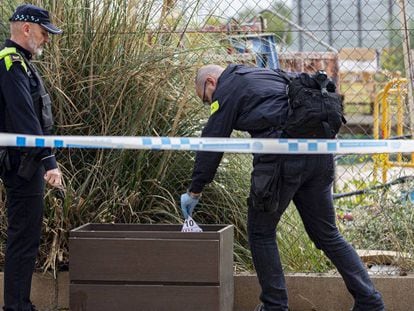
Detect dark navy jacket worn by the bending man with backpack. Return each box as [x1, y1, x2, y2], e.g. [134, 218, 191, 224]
[189, 65, 288, 193]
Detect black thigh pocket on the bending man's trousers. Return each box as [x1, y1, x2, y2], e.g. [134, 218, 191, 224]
[248, 159, 280, 213]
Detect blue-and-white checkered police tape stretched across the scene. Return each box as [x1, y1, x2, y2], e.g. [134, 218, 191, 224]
[0, 133, 414, 154]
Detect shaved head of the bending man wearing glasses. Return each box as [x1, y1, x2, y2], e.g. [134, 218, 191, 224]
[195, 64, 224, 103]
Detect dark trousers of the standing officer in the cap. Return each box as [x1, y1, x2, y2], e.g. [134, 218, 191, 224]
[3, 156, 45, 311]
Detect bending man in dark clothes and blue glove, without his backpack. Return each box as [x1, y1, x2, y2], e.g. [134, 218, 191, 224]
[181, 65, 384, 311]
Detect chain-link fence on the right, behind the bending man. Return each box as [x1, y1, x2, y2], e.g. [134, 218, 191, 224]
[150, 0, 414, 274]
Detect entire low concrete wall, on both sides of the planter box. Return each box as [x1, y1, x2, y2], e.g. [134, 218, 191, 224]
[0, 272, 414, 311]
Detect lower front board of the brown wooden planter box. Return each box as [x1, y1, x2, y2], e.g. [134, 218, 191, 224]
[70, 284, 233, 311]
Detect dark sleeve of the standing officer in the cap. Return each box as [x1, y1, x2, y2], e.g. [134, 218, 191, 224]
[0, 62, 57, 170]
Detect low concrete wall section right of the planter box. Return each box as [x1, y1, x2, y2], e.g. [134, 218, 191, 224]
[234, 273, 414, 311]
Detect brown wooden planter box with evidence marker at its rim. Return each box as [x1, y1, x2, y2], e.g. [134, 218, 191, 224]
[69, 224, 234, 311]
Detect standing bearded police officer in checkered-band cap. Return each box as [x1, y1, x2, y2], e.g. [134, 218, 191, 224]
[0, 4, 62, 311]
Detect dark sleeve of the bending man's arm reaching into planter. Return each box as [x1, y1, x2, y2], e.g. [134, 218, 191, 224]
[189, 76, 243, 193]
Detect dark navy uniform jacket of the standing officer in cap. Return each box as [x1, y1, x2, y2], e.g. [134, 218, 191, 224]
[0, 40, 57, 170]
